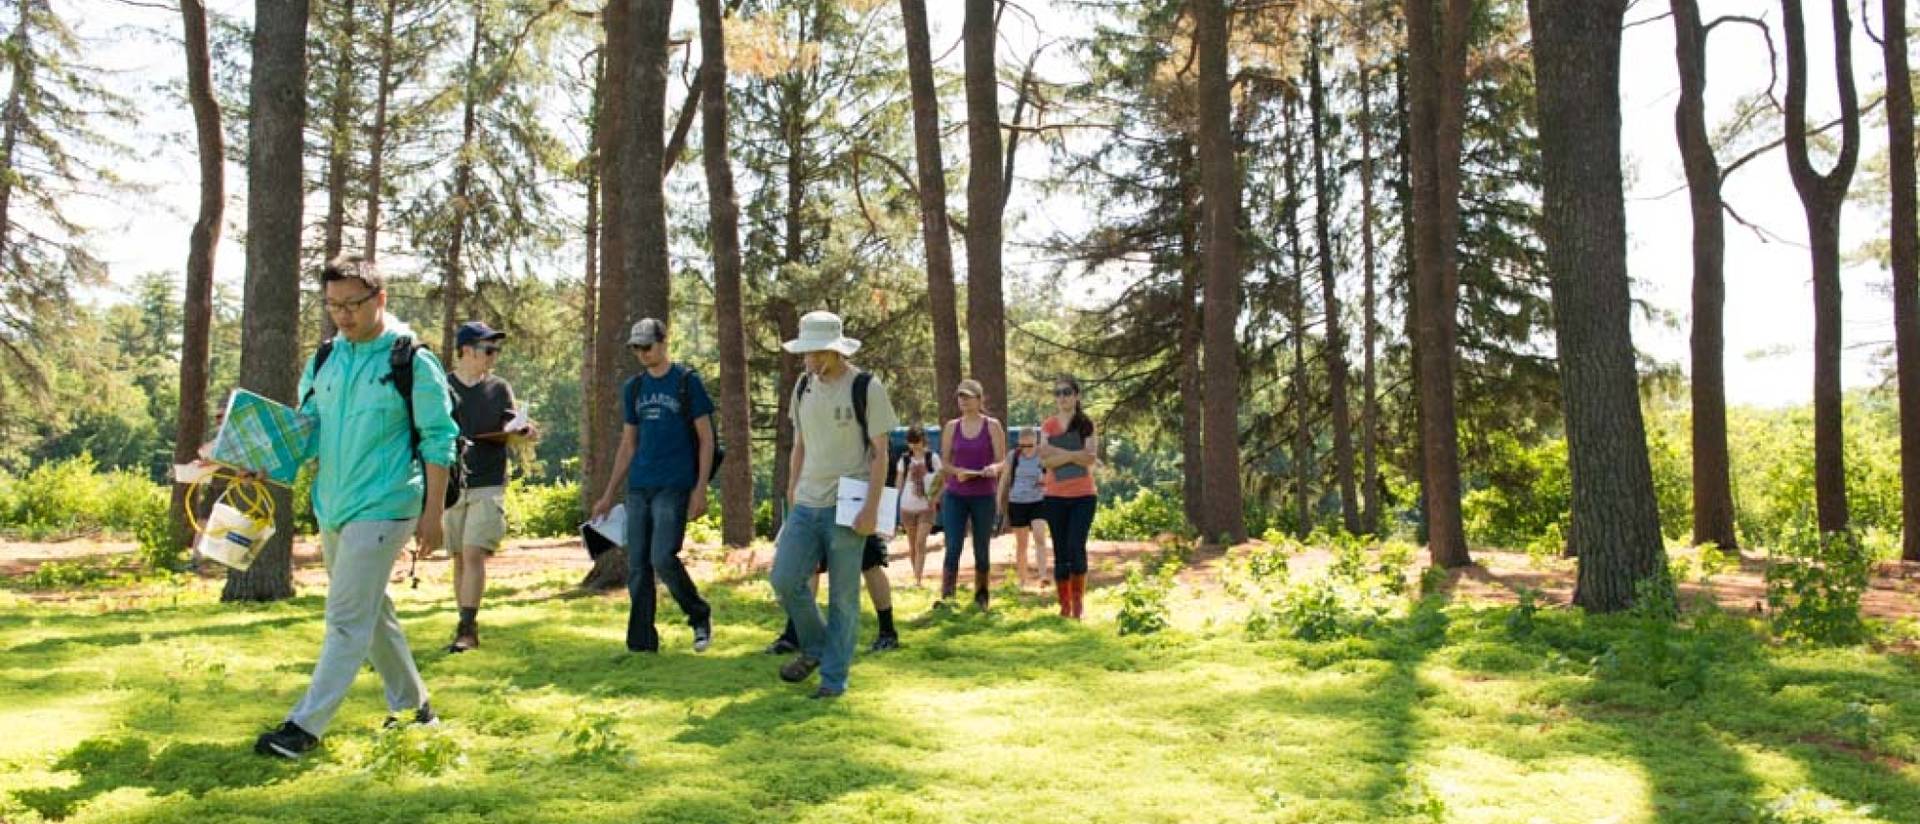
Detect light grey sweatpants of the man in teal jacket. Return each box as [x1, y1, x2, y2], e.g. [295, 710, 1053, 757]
[286, 521, 426, 738]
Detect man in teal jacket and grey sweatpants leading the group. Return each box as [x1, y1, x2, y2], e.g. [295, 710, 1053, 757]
[253, 255, 459, 759]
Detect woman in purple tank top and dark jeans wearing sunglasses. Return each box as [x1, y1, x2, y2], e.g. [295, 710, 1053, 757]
[933, 378, 1006, 609]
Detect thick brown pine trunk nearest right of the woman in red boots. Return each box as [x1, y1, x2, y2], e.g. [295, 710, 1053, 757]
[1190, 0, 1246, 544]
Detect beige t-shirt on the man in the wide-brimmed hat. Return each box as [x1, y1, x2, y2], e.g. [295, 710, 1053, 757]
[793, 363, 900, 507]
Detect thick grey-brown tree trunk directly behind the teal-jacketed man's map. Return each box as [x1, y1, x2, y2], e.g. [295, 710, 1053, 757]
[221, 0, 307, 601]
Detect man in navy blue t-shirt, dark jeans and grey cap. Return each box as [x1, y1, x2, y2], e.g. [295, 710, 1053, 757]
[593, 317, 714, 653]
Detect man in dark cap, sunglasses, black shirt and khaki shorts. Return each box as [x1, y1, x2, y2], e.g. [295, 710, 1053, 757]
[444, 321, 534, 653]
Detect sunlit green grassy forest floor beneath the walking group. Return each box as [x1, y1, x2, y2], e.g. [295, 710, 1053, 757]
[0, 530, 1920, 824]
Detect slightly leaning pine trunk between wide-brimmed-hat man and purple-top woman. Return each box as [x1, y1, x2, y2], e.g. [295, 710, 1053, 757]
[900, 0, 960, 421]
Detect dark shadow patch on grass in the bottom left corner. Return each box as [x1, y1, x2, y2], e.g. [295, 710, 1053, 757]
[13, 738, 311, 820]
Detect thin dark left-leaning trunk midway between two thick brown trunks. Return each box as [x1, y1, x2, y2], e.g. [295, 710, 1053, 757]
[1308, 33, 1359, 534]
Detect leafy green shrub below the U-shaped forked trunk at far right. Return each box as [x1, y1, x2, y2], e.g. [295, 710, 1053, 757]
[1766, 526, 1874, 643]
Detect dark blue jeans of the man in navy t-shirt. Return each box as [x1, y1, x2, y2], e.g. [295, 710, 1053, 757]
[626, 488, 712, 651]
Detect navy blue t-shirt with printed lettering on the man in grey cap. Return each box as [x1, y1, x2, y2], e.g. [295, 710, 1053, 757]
[620, 363, 714, 490]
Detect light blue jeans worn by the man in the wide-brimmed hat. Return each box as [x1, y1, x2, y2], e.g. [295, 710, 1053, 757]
[772, 507, 866, 690]
